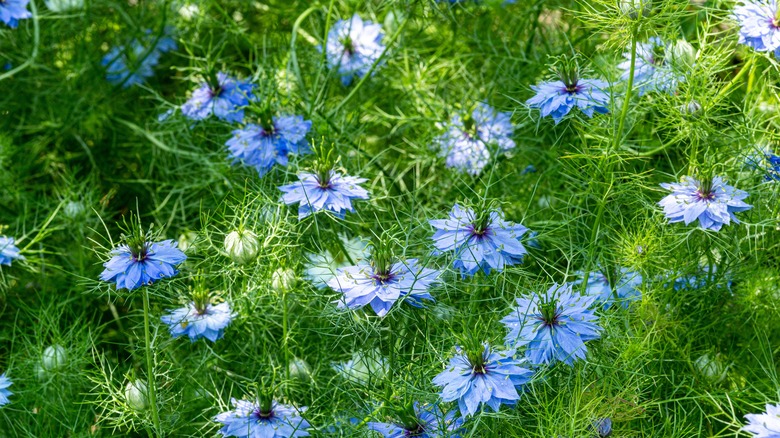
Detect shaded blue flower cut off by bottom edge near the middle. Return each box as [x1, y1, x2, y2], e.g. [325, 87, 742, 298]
[368, 402, 463, 438]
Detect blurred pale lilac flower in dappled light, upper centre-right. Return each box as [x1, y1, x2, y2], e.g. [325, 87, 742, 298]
[433, 103, 515, 175]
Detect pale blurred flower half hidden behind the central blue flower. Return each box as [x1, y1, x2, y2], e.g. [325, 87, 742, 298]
[304, 234, 370, 288]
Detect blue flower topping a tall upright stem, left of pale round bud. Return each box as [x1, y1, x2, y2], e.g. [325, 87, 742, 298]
[100, 240, 187, 290]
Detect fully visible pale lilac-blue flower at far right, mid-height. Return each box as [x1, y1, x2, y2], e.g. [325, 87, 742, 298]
[658, 176, 753, 231]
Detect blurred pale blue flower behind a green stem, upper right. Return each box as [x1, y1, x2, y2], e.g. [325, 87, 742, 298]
[618, 37, 685, 96]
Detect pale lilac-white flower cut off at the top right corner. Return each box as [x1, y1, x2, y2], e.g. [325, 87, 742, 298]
[734, 0, 780, 58]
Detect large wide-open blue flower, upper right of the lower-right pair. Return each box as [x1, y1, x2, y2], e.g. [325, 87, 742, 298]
[501, 283, 601, 365]
